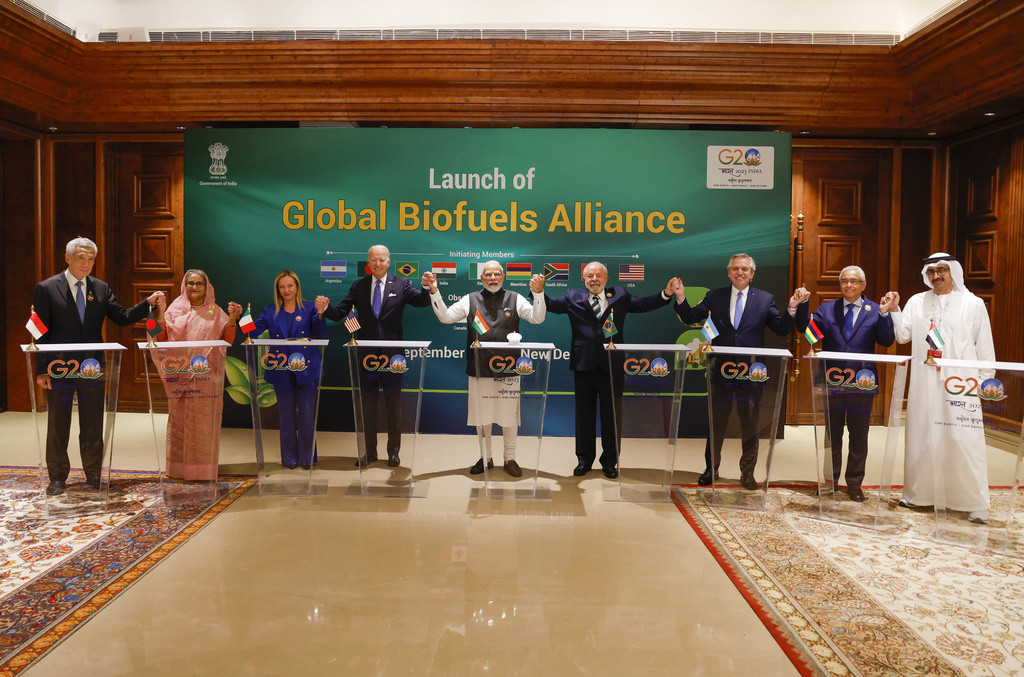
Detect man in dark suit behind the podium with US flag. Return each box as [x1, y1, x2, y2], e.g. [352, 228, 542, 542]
[315, 245, 430, 468]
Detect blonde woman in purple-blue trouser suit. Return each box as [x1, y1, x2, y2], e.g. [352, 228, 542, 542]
[252, 270, 327, 470]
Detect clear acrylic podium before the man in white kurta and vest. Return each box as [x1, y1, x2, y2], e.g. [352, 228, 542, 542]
[467, 341, 555, 500]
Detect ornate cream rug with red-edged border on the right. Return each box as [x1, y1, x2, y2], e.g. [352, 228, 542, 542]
[676, 488, 1024, 676]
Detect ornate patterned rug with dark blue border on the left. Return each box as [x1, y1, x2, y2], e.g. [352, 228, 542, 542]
[0, 468, 256, 676]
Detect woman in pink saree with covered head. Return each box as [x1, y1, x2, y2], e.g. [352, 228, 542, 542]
[153, 269, 242, 480]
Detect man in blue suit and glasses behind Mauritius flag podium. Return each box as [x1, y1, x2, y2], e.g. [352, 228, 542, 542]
[797, 265, 896, 502]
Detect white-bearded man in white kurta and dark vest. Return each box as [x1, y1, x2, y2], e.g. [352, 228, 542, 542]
[422, 261, 545, 477]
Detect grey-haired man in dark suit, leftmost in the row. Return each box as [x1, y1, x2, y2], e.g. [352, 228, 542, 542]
[33, 238, 164, 496]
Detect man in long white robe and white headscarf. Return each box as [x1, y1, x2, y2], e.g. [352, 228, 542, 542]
[892, 252, 995, 523]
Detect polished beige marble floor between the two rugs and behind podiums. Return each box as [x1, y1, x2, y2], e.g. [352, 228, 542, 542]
[0, 413, 1009, 677]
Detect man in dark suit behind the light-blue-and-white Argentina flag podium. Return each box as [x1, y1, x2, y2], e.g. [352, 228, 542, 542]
[676, 254, 810, 490]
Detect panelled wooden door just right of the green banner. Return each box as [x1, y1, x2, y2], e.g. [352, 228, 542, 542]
[786, 149, 892, 424]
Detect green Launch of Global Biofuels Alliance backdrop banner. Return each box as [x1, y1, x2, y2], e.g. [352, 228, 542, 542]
[184, 128, 792, 434]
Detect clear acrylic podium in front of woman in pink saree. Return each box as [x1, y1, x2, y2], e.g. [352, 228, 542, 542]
[137, 340, 230, 504]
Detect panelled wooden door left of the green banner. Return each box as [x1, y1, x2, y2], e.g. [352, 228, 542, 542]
[105, 143, 184, 412]
